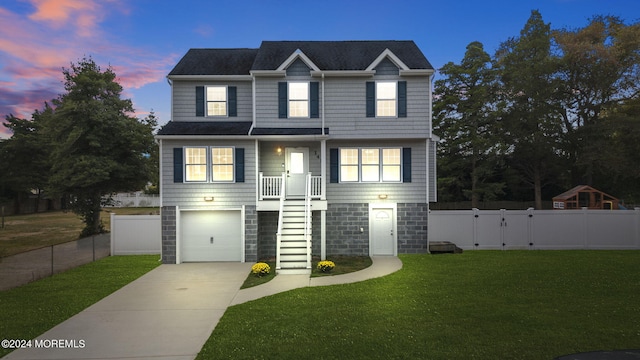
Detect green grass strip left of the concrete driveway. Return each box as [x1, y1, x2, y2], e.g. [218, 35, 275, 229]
[0, 255, 160, 357]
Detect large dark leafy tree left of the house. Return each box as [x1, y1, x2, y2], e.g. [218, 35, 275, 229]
[46, 58, 155, 236]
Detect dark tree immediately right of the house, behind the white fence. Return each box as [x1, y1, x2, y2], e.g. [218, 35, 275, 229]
[434, 42, 504, 207]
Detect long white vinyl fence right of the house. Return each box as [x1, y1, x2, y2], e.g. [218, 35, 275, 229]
[428, 208, 640, 250]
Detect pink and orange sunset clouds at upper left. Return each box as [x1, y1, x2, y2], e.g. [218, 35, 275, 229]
[0, 0, 176, 138]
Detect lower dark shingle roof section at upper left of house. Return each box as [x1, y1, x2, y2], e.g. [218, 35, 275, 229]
[169, 49, 258, 76]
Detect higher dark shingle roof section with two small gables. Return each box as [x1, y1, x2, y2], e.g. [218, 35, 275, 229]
[251, 41, 433, 70]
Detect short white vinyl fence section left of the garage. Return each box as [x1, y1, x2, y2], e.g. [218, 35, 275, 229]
[111, 213, 162, 255]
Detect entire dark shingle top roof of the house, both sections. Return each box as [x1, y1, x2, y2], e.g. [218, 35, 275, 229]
[169, 41, 433, 76]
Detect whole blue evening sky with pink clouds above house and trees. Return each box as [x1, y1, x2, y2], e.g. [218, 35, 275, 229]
[0, 0, 640, 138]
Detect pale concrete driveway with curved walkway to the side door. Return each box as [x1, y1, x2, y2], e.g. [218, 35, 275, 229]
[3, 257, 402, 360]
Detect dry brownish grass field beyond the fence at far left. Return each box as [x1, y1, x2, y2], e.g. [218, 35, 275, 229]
[0, 208, 158, 257]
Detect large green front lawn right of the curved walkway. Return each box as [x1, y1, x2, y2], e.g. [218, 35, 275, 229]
[198, 251, 640, 360]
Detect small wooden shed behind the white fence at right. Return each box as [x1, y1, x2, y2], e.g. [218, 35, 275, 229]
[553, 185, 619, 210]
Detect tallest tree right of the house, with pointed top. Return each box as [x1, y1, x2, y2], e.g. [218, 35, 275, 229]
[495, 10, 562, 209]
